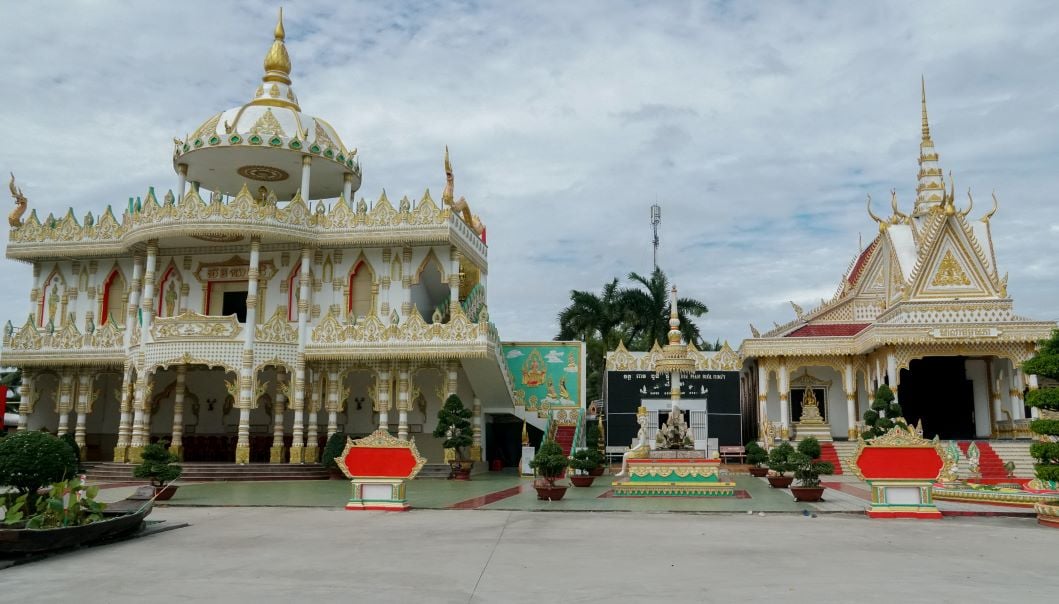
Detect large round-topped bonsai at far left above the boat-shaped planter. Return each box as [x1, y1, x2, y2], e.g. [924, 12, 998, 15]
[0, 431, 77, 502]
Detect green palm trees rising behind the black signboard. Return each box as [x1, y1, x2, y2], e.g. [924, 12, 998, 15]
[617, 268, 708, 350]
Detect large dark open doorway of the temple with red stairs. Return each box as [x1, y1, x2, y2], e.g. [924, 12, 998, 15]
[898, 356, 975, 440]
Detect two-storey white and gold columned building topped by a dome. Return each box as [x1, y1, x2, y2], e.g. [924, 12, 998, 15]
[2, 13, 515, 463]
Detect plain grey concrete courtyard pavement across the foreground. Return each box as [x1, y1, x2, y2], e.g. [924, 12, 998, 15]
[0, 507, 1059, 603]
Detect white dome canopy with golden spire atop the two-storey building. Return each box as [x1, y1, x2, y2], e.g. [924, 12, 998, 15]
[173, 8, 360, 201]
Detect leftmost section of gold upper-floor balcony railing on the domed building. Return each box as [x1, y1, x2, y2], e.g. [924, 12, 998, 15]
[0, 317, 125, 367]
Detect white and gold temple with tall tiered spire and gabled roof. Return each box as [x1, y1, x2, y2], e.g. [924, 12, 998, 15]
[739, 81, 1056, 441]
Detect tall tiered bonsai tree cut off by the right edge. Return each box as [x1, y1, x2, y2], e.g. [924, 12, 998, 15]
[1022, 330, 1059, 483]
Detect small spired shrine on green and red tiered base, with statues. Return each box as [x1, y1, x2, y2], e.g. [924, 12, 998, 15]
[612, 287, 735, 497]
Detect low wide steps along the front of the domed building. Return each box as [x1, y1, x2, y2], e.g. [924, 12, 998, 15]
[85, 462, 330, 484]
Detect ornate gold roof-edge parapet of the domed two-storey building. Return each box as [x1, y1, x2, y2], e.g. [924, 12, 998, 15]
[7, 186, 488, 266]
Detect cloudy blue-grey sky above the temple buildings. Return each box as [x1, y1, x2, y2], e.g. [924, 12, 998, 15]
[0, 0, 1059, 347]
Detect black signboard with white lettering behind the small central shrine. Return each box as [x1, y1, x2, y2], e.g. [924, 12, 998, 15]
[606, 371, 742, 446]
